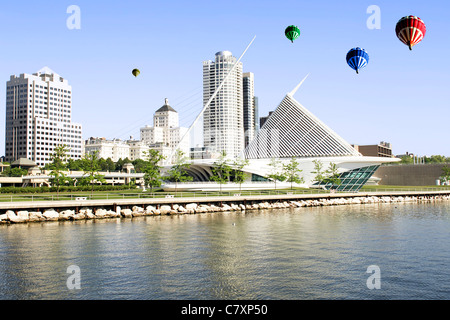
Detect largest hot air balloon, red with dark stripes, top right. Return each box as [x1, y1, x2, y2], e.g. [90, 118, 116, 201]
[395, 16, 427, 50]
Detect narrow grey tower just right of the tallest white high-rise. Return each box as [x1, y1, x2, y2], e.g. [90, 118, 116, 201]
[242, 72, 258, 147]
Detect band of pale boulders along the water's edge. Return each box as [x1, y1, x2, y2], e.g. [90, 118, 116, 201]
[0, 195, 450, 224]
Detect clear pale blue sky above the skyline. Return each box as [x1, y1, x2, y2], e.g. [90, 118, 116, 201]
[0, 0, 450, 156]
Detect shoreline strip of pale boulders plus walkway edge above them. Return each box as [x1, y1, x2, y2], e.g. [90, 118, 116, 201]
[0, 192, 450, 225]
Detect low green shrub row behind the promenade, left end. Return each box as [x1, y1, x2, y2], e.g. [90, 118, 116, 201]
[0, 185, 136, 193]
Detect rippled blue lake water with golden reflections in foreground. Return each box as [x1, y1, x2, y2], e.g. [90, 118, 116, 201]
[0, 202, 450, 300]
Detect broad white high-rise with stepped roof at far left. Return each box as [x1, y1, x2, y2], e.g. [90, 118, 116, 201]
[5, 67, 83, 166]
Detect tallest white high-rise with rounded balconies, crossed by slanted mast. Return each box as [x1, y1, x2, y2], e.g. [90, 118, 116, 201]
[203, 51, 245, 157]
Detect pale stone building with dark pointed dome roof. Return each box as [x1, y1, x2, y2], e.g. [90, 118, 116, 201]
[140, 99, 190, 164]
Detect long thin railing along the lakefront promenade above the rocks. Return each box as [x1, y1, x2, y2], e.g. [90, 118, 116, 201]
[0, 186, 450, 202]
